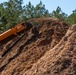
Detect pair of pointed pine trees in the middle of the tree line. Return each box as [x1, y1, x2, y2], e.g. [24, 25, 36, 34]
[24, 1, 50, 19]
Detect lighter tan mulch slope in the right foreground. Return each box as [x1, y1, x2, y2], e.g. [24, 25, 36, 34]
[24, 24, 76, 75]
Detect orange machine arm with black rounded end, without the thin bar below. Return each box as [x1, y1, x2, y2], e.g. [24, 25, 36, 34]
[0, 22, 32, 44]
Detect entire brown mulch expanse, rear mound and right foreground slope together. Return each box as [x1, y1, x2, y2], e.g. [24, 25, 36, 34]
[0, 18, 76, 75]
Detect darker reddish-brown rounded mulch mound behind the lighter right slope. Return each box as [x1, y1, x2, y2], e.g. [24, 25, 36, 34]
[0, 18, 69, 75]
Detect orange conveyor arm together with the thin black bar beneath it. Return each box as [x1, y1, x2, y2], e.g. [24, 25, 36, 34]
[0, 22, 33, 57]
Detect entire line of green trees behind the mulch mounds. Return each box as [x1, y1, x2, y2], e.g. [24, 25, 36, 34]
[0, 0, 76, 31]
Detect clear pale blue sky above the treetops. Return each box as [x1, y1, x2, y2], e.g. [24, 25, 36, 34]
[0, 0, 76, 15]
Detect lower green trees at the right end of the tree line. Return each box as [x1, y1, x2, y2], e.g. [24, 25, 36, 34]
[51, 6, 76, 25]
